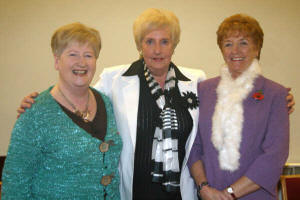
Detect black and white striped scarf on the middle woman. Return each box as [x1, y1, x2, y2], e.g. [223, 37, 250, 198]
[144, 64, 180, 192]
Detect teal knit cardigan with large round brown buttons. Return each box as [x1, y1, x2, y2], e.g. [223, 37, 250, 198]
[2, 87, 122, 200]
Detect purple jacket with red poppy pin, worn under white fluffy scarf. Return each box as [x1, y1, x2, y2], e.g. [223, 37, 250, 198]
[188, 76, 289, 200]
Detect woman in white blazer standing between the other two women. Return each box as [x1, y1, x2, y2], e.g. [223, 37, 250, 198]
[95, 9, 205, 200]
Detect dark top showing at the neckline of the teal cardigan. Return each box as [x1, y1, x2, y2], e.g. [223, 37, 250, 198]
[58, 89, 107, 140]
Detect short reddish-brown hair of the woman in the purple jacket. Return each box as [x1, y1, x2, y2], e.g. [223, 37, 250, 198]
[217, 14, 264, 57]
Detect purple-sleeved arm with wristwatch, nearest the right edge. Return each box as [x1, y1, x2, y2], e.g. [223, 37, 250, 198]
[239, 87, 289, 197]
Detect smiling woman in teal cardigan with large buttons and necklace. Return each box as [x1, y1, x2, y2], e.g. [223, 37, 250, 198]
[2, 23, 122, 200]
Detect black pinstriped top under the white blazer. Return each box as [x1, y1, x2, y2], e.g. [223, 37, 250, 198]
[125, 61, 193, 200]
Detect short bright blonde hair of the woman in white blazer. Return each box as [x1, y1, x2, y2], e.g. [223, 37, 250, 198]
[133, 8, 180, 51]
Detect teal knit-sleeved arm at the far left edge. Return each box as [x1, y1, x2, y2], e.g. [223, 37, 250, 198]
[2, 111, 41, 199]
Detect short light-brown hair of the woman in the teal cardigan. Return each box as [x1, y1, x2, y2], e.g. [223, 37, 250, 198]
[51, 22, 101, 58]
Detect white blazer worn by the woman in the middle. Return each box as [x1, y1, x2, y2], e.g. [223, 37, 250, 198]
[95, 65, 206, 200]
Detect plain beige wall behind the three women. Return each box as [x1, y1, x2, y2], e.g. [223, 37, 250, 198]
[0, 0, 300, 162]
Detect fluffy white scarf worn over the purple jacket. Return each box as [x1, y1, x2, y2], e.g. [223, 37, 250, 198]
[211, 59, 261, 172]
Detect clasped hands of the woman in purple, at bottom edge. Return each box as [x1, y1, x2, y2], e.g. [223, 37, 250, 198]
[199, 186, 233, 200]
